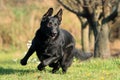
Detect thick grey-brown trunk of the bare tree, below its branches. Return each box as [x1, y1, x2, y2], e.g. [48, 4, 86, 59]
[94, 24, 110, 58]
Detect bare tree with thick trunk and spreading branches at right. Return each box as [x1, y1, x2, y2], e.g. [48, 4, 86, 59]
[58, 0, 120, 58]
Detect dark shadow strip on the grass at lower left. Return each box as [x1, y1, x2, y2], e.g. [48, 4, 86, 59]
[0, 67, 34, 75]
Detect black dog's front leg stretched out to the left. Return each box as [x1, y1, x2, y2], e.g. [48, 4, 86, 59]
[20, 45, 35, 65]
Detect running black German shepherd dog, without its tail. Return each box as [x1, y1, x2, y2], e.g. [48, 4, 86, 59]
[20, 8, 79, 73]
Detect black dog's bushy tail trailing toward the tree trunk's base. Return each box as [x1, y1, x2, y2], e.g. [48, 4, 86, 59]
[74, 49, 93, 60]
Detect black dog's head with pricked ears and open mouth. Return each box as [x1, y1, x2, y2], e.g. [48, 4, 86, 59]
[40, 8, 63, 39]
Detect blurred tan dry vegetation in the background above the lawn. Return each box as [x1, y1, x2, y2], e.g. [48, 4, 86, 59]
[0, 0, 120, 53]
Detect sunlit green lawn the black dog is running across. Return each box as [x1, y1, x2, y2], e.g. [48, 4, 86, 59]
[0, 51, 120, 80]
